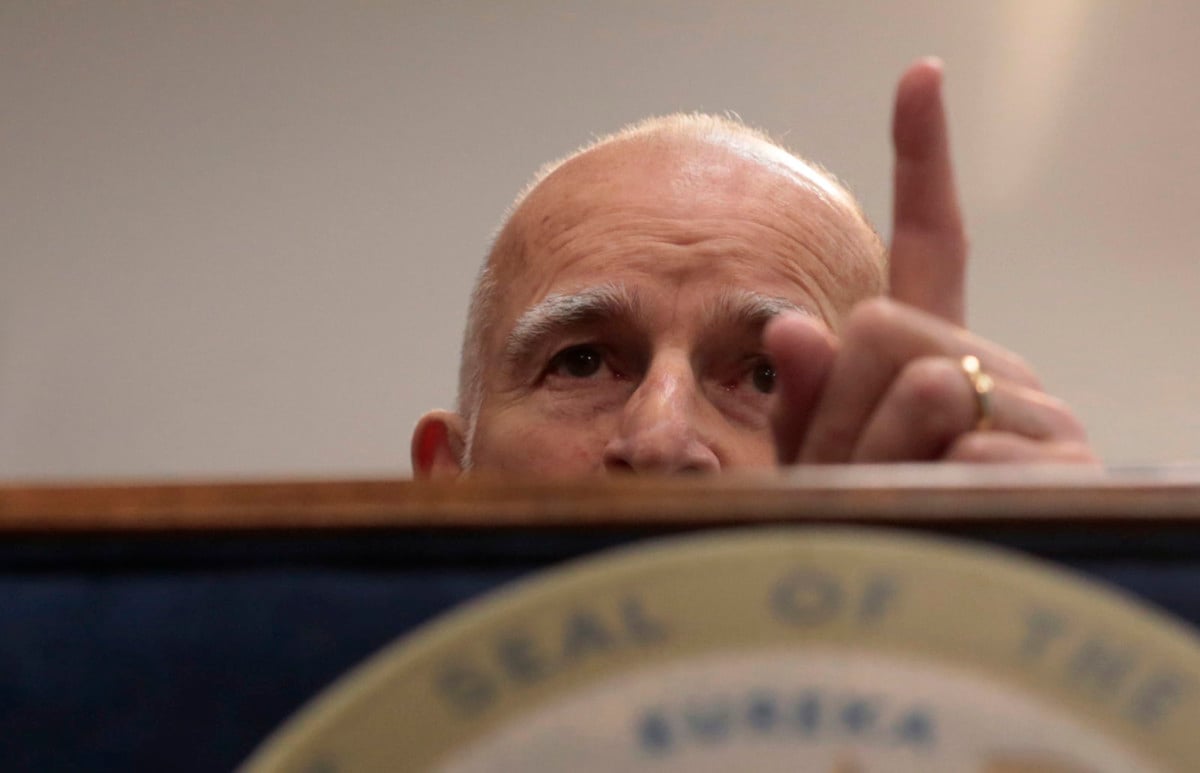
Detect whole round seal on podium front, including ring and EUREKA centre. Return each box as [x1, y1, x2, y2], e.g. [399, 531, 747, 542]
[238, 528, 1200, 773]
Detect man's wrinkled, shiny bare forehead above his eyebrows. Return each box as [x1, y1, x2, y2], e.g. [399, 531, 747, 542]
[492, 137, 880, 335]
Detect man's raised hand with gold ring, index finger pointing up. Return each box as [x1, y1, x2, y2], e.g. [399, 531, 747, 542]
[764, 60, 1096, 463]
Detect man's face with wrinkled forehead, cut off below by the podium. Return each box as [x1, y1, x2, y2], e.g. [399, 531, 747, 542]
[468, 139, 881, 477]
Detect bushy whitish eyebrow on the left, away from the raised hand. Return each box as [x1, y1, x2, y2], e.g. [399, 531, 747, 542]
[504, 283, 641, 361]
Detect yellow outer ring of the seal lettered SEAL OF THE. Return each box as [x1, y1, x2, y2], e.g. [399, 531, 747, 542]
[244, 527, 1200, 772]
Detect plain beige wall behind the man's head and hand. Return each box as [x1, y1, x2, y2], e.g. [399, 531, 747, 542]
[0, 0, 1200, 479]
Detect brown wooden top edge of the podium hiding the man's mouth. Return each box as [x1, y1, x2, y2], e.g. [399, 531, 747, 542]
[0, 465, 1200, 534]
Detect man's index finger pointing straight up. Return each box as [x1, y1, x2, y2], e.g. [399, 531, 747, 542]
[889, 59, 967, 325]
